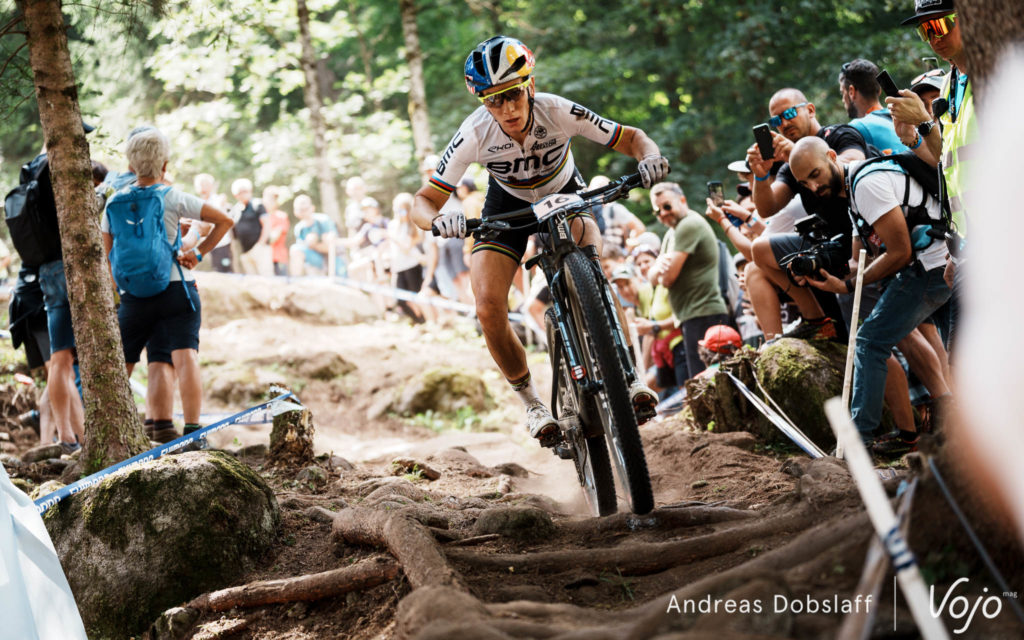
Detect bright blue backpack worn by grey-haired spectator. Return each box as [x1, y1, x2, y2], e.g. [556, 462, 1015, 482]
[106, 184, 195, 306]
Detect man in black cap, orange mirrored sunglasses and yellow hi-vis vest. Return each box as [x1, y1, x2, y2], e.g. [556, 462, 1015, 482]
[886, 0, 978, 347]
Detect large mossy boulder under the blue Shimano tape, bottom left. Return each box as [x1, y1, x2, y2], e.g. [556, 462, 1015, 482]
[44, 452, 280, 640]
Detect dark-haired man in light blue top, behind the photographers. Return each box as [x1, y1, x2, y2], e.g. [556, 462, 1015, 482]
[839, 57, 906, 156]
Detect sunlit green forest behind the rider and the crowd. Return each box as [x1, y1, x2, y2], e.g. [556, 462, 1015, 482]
[0, 0, 945, 222]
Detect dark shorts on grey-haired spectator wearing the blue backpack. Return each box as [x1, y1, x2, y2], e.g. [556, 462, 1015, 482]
[118, 281, 203, 364]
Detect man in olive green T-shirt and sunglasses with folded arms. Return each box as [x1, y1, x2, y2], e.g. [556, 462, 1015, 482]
[647, 182, 729, 385]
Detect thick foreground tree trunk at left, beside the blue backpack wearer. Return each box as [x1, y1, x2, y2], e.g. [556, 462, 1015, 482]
[17, 0, 148, 473]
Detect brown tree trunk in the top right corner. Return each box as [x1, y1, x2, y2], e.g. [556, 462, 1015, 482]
[956, 0, 1024, 106]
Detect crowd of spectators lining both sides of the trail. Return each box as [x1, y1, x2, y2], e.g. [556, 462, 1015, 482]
[0, 0, 974, 455]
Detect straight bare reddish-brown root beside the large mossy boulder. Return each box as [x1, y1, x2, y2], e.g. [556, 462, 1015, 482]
[186, 558, 398, 612]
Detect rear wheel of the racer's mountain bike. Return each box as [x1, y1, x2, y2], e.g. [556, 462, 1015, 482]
[544, 309, 616, 516]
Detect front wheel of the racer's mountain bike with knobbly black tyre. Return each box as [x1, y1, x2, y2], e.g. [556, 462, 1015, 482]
[565, 251, 654, 513]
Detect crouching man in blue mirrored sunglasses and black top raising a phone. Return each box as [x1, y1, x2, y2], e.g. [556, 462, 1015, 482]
[746, 88, 867, 340]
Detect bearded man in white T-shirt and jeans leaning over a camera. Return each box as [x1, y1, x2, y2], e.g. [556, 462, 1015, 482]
[791, 138, 950, 454]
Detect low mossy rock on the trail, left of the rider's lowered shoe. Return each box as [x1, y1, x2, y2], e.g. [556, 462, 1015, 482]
[394, 369, 494, 416]
